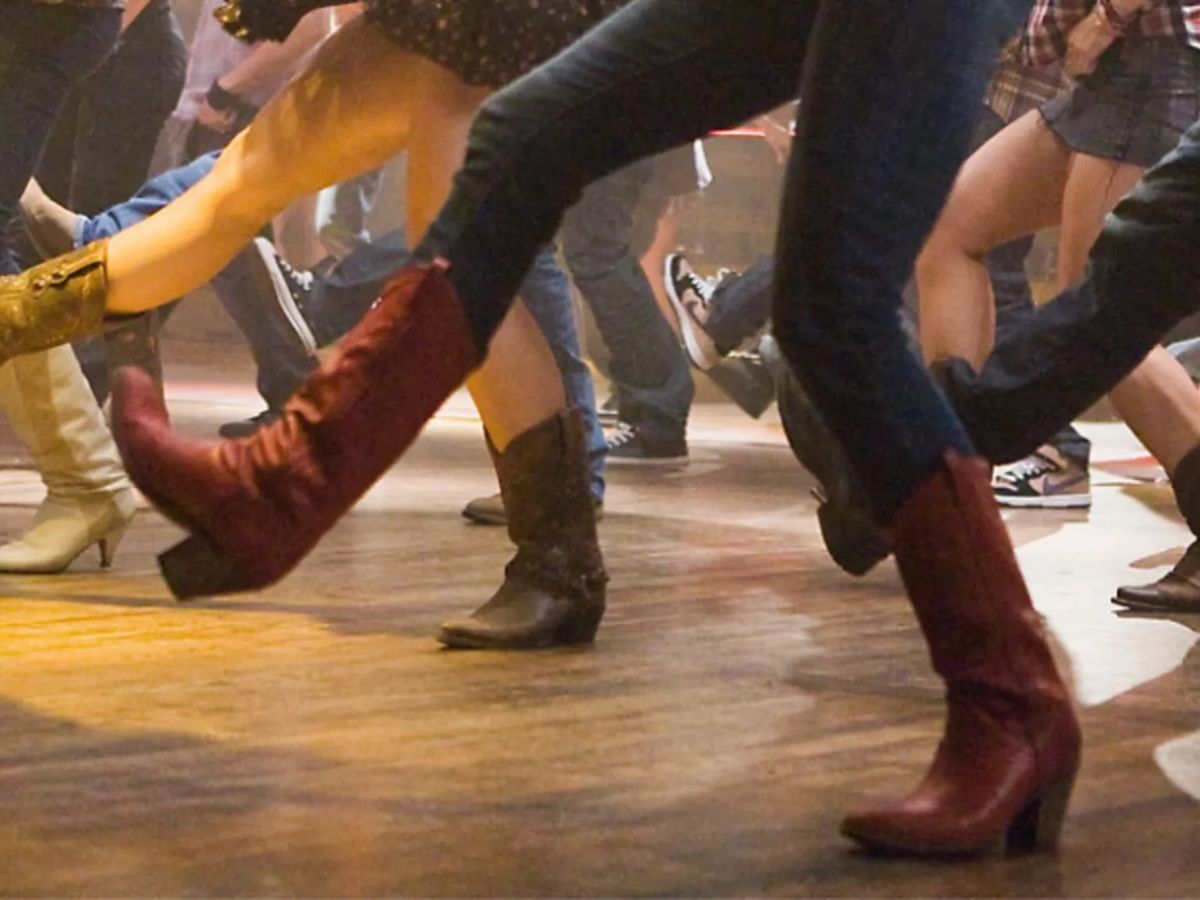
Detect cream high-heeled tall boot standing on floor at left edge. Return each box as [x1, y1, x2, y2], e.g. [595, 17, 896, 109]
[0, 346, 137, 574]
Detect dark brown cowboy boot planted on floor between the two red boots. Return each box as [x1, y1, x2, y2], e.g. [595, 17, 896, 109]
[438, 410, 608, 649]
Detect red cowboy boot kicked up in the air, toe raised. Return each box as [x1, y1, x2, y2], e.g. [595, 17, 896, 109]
[113, 265, 480, 599]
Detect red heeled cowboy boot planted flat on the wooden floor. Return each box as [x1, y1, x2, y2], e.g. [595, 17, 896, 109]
[842, 452, 1080, 854]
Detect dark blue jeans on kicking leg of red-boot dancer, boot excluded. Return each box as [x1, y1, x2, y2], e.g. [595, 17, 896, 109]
[416, 0, 817, 349]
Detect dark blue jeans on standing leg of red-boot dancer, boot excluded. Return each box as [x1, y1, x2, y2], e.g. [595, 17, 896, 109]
[774, 0, 1018, 522]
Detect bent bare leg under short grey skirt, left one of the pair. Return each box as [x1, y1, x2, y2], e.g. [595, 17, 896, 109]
[917, 112, 1070, 367]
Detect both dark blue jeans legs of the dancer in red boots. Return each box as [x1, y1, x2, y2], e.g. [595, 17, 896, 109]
[418, 0, 1030, 521]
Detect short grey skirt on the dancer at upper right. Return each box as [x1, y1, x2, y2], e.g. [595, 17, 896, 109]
[1040, 37, 1200, 168]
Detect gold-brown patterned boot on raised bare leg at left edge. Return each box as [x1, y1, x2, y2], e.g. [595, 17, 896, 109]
[0, 241, 108, 362]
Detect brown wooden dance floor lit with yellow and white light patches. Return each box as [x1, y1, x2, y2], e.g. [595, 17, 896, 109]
[0, 350, 1200, 896]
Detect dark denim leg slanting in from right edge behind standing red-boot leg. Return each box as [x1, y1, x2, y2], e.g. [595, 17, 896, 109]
[947, 122, 1200, 461]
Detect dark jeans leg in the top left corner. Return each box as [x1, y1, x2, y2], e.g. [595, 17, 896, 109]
[0, 1, 121, 275]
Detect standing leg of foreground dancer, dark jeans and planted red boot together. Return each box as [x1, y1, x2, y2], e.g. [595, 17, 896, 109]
[775, 0, 1079, 853]
